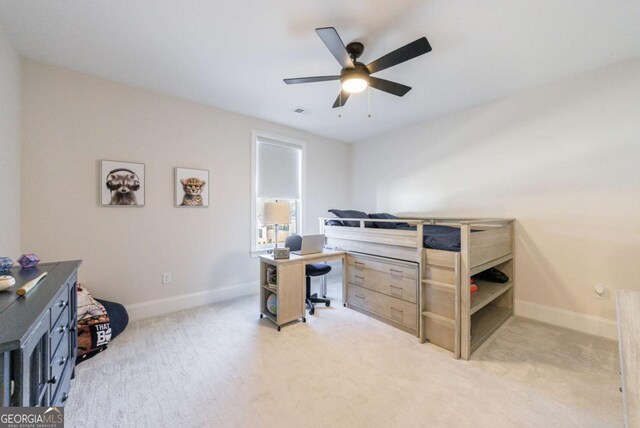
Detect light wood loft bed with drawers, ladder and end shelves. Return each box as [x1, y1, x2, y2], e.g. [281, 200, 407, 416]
[319, 216, 515, 360]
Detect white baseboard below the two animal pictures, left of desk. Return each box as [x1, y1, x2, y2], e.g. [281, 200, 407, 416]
[125, 282, 258, 321]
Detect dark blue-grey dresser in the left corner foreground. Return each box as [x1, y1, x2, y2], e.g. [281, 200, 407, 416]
[0, 260, 81, 407]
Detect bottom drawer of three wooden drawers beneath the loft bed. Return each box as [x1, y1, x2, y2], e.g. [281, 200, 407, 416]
[347, 284, 417, 329]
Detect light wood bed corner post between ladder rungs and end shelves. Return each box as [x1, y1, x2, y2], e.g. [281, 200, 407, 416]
[460, 221, 471, 360]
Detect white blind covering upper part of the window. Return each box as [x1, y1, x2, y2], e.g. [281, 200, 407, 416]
[256, 138, 302, 199]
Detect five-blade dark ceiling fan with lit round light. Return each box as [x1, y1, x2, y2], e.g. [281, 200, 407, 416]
[284, 27, 431, 108]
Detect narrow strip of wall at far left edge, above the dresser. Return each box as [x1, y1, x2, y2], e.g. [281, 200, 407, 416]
[0, 30, 20, 261]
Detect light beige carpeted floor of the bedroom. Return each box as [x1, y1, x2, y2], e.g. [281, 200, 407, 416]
[65, 280, 622, 428]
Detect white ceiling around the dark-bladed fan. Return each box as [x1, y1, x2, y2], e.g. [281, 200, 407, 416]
[0, 0, 640, 141]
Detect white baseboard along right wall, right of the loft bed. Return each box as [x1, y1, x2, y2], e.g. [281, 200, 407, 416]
[515, 300, 618, 340]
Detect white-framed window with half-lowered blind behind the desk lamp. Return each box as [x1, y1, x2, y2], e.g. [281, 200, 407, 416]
[251, 131, 305, 253]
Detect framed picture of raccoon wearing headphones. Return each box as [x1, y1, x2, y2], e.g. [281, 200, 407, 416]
[99, 159, 146, 207]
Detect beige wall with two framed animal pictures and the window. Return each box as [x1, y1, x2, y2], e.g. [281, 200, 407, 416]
[22, 60, 351, 310]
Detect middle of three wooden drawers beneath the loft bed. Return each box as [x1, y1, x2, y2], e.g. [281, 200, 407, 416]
[347, 265, 418, 303]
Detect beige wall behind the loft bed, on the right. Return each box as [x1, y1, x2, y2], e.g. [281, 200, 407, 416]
[352, 59, 640, 324]
